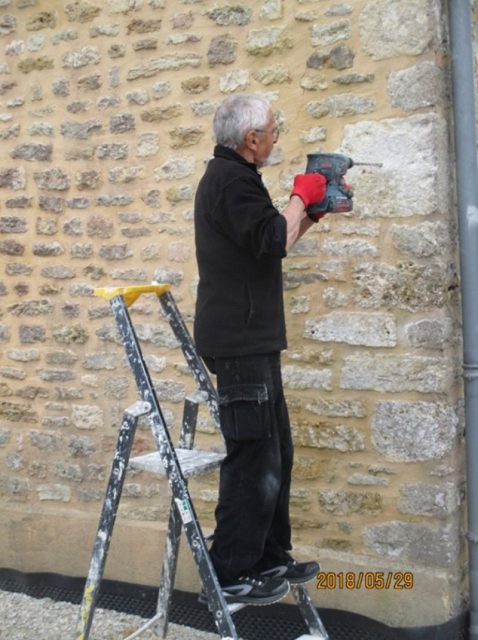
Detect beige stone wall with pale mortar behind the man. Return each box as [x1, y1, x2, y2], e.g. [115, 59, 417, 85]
[0, 0, 465, 626]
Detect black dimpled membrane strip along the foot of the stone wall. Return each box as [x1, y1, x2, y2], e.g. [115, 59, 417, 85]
[0, 569, 468, 640]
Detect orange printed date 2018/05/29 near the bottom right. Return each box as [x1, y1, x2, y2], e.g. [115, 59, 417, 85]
[316, 571, 413, 591]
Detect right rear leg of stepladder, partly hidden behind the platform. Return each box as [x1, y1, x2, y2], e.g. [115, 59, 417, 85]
[154, 397, 199, 638]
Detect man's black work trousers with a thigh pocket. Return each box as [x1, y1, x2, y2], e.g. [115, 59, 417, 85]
[206, 353, 293, 584]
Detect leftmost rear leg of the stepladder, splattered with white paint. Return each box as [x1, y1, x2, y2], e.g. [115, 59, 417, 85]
[75, 403, 148, 640]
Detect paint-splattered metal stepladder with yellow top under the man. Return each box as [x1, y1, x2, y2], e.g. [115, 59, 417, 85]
[74, 284, 329, 640]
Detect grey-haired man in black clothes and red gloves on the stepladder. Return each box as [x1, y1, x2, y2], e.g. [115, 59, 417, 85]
[194, 94, 326, 604]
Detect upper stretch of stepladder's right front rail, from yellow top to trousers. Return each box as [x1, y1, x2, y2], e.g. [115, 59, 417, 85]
[158, 291, 220, 430]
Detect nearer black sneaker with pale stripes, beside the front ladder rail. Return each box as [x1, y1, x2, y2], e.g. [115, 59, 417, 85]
[198, 576, 290, 606]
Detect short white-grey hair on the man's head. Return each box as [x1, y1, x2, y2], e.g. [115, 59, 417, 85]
[213, 93, 271, 150]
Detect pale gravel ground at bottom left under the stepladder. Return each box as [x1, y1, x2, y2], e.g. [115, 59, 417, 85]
[0, 591, 225, 640]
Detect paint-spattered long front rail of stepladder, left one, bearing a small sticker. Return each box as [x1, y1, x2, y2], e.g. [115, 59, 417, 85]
[111, 295, 238, 640]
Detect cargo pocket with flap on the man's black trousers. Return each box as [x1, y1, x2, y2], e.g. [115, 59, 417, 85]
[219, 384, 271, 440]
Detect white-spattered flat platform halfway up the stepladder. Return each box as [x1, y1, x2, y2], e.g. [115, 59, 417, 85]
[129, 449, 226, 478]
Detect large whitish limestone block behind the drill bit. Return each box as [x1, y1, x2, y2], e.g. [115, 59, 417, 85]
[342, 113, 450, 217]
